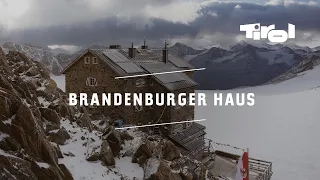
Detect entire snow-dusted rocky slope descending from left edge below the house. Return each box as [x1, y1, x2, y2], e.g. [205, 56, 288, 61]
[0, 48, 212, 180]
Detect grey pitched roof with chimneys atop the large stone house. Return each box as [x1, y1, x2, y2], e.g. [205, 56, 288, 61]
[63, 49, 198, 91]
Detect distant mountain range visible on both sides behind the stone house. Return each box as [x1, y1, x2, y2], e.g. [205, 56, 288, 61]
[1, 42, 320, 90]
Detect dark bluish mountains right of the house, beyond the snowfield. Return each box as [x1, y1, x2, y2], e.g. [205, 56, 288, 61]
[171, 42, 320, 90]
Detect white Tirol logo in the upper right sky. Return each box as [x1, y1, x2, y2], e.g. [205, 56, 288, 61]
[240, 23, 295, 43]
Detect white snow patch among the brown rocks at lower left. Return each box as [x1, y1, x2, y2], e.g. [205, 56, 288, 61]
[59, 120, 144, 180]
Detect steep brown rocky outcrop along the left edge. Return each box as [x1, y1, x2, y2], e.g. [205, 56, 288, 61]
[0, 48, 94, 180]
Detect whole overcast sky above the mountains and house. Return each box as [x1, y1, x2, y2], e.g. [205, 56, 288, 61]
[0, 0, 320, 48]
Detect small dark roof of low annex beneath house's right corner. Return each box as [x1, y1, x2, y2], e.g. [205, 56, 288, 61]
[169, 123, 206, 151]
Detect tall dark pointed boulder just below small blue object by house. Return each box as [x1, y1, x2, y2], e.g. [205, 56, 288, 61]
[103, 127, 121, 156]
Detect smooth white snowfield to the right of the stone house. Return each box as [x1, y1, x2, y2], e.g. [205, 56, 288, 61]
[196, 67, 320, 180]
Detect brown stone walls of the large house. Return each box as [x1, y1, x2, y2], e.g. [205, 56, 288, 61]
[64, 51, 194, 129]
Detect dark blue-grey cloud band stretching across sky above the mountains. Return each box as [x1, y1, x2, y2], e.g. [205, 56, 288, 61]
[0, 0, 320, 46]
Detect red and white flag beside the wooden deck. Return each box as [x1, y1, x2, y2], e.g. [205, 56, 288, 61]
[235, 152, 249, 180]
